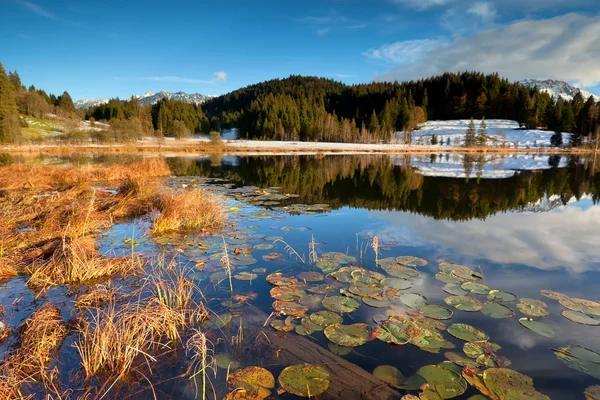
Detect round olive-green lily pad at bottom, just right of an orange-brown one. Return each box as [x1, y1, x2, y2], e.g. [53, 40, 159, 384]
[278, 364, 329, 397]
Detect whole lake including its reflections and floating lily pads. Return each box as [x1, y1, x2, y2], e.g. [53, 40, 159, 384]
[0, 154, 600, 399]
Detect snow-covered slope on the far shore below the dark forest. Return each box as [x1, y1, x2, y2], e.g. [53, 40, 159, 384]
[413, 119, 570, 148]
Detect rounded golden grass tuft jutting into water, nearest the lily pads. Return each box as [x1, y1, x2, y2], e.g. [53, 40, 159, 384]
[152, 190, 225, 234]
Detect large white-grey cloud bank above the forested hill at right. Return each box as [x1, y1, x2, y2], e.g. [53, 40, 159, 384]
[376, 13, 600, 86]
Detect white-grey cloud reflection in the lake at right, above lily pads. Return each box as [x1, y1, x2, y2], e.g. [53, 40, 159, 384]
[371, 207, 600, 273]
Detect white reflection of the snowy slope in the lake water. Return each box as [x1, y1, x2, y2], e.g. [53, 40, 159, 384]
[408, 153, 567, 179]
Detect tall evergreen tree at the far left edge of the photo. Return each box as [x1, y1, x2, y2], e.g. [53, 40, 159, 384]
[0, 63, 21, 143]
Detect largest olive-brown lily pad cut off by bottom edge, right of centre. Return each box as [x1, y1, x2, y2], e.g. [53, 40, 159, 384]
[483, 368, 550, 400]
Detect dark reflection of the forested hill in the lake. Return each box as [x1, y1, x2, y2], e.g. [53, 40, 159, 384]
[169, 155, 600, 220]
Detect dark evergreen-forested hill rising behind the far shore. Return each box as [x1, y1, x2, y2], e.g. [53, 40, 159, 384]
[203, 72, 596, 142]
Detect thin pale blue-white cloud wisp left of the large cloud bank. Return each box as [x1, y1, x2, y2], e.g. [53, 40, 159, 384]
[363, 39, 444, 64]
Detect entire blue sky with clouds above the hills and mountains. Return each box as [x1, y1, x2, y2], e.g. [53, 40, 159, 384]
[0, 0, 600, 99]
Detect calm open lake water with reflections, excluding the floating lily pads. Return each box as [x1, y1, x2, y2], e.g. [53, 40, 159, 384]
[0, 155, 600, 399]
